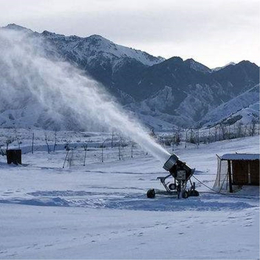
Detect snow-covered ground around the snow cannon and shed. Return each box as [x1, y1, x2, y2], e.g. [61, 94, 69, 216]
[0, 132, 259, 259]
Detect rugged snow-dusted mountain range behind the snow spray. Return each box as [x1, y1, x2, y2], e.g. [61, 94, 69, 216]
[0, 24, 259, 129]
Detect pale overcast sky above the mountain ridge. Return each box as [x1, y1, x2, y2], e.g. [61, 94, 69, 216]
[0, 0, 260, 68]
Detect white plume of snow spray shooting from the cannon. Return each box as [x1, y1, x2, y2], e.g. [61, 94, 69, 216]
[0, 29, 170, 162]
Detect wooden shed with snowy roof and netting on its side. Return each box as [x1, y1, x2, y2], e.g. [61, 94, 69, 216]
[214, 153, 260, 192]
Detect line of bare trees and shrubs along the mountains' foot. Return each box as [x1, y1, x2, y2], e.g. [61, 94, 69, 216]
[0, 121, 260, 167]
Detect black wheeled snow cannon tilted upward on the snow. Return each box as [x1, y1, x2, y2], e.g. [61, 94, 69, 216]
[147, 154, 199, 199]
